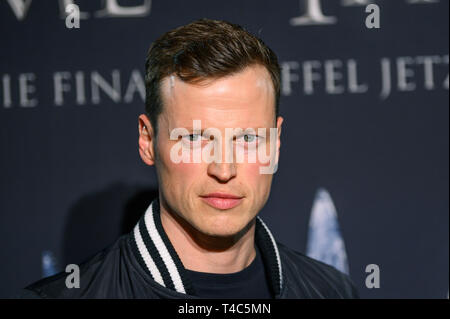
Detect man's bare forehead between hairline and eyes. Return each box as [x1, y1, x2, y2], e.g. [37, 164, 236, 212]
[161, 65, 275, 129]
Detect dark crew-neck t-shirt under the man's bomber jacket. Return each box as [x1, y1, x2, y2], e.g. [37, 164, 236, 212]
[186, 247, 273, 299]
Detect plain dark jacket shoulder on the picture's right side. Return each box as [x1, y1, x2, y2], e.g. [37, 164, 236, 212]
[277, 242, 359, 299]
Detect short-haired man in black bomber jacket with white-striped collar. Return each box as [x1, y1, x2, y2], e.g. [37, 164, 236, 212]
[19, 19, 357, 298]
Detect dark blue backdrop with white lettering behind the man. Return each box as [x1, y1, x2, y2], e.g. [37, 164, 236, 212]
[0, 0, 449, 298]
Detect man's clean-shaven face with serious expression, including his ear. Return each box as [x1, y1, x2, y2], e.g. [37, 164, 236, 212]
[139, 65, 283, 236]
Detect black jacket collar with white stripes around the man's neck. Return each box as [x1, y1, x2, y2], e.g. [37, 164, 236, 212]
[131, 198, 283, 296]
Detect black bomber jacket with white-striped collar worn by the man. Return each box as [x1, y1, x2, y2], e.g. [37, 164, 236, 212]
[18, 199, 359, 299]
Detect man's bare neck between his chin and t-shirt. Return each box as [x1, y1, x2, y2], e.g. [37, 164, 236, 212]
[159, 199, 256, 274]
